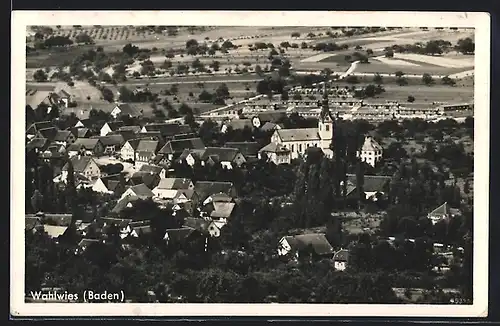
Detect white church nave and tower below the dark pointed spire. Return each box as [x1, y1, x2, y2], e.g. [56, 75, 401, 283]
[271, 113, 333, 159]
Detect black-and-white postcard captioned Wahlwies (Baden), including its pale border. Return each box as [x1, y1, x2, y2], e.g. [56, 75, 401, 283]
[11, 11, 490, 316]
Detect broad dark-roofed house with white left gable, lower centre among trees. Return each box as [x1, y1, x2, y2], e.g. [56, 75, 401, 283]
[278, 233, 335, 258]
